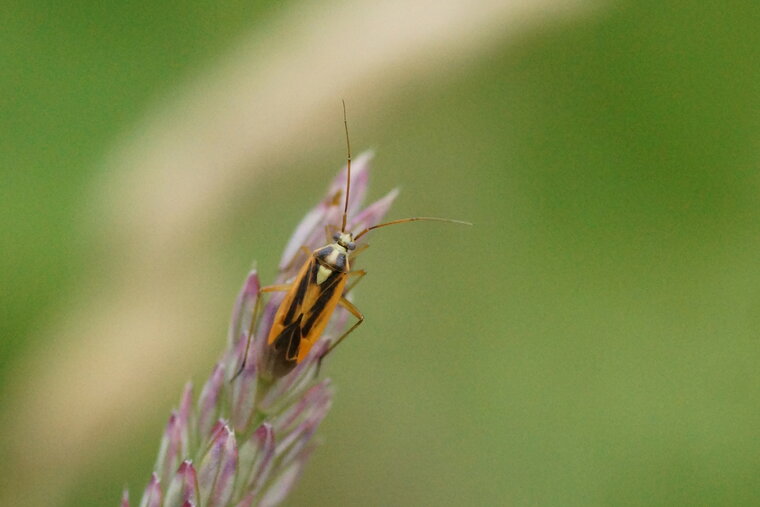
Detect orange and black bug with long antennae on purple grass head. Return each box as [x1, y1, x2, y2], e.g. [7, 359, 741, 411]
[233, 102, 472, 380]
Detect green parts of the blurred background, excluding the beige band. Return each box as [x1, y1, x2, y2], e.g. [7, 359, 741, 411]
[0, 0, 760, 506]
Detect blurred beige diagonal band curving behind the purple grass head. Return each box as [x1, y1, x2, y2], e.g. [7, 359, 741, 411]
[0, 0, 589, 505]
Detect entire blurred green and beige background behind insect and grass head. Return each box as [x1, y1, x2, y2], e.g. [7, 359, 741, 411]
[0, 0, 760, 506]
